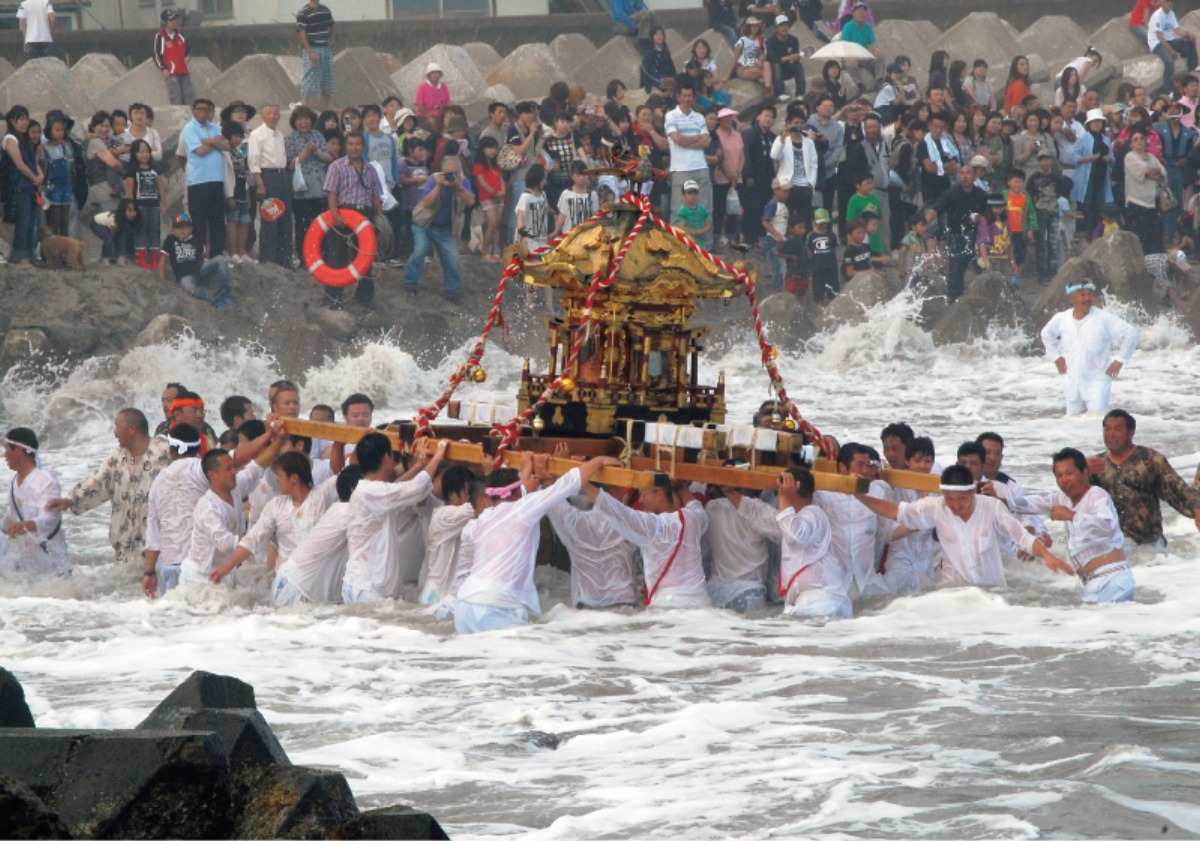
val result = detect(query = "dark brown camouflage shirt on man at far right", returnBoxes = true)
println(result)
[1092,446,1198,543]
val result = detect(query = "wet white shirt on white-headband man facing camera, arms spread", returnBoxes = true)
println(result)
[896,495,1033,587]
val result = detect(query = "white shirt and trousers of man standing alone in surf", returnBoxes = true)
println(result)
[1042,307,1138,413]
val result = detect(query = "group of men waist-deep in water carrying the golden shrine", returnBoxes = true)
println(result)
[0,380,1200,632]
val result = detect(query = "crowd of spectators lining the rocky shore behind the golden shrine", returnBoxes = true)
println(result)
[0,0,1200,307]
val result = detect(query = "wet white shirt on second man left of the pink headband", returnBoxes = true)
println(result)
[344,471,433,599]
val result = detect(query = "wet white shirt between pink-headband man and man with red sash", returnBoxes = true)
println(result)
[547,500,642,607]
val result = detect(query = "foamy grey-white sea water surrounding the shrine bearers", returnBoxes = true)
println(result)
[0,291,1200,840]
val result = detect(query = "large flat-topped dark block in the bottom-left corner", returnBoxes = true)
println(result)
[0,729,233,839]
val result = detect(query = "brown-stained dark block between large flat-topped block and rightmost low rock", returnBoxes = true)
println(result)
[234,765,359,839]
